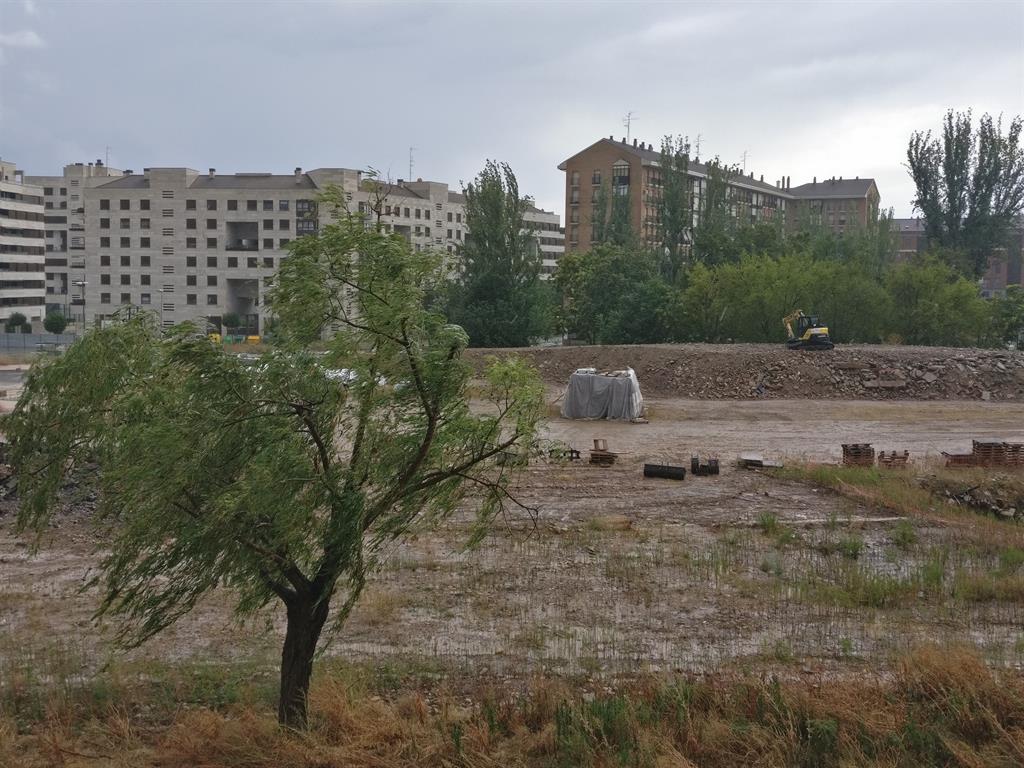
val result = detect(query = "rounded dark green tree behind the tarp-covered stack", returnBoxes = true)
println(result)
[555,245,680,344]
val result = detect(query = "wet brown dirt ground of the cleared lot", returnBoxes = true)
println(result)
[0,397,1024,681]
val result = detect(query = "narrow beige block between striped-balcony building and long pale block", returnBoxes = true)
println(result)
[26,160,122,324]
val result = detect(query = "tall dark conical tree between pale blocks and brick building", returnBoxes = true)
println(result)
[449,160,549,347]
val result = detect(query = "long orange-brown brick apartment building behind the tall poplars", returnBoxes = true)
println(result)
[558,136,879,251]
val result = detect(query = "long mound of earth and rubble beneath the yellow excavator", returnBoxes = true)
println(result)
[470,344,1024,400]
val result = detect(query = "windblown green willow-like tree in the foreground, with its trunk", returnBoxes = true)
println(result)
[5,204,544,727]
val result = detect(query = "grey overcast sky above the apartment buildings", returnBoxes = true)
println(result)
[0,0,1024,216]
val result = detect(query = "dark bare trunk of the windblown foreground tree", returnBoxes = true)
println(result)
[278,597,330,730]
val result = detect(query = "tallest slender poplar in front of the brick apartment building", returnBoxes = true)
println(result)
[657,136,693,284]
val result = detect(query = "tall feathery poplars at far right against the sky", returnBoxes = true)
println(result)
[906,110,1024,278]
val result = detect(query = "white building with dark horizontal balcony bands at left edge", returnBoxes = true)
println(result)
[0,160,46,331]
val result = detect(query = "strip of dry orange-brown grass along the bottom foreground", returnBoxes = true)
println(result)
[0,647,1024,768]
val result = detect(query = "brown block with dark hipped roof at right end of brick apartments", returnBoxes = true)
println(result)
[786,176,881,233]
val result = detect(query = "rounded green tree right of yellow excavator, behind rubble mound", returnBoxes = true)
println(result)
[886,254,989,346]
